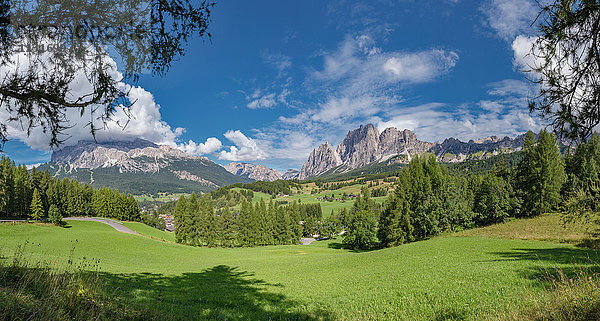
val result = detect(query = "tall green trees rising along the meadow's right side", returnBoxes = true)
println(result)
[368,130,600,248]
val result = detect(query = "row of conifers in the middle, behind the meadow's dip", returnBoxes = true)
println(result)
[174,194,332,247]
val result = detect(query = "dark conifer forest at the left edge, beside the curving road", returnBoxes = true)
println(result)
[0,157,140,223]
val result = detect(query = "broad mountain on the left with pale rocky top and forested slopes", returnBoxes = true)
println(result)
[38,139,252,194]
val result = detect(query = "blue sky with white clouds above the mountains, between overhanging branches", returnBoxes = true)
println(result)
[5,0,541,170]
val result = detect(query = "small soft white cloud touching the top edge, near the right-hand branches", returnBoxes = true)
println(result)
[482,0,539,41]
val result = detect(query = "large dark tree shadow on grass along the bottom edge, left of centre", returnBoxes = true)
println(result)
[103,265,335,320]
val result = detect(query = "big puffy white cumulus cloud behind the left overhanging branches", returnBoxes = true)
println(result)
[0,48,220,155]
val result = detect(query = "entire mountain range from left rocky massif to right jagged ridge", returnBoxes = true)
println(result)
[38,124,524,194]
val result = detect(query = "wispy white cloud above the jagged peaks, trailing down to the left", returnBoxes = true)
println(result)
[246,34,459,166]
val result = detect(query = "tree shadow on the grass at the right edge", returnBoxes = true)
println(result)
[492,247,600,286]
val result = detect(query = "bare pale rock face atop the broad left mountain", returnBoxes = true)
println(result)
[52,139,210,173]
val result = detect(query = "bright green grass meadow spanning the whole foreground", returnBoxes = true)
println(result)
[0,216,600,320]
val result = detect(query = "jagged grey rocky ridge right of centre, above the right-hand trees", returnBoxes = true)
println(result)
[299,124,525,179]
